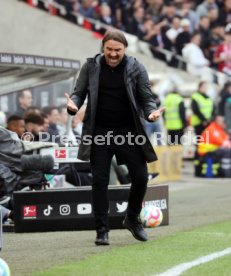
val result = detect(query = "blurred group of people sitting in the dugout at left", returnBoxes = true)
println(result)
[1,89,84,146]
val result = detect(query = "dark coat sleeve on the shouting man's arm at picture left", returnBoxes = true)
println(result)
[69,63,89,114]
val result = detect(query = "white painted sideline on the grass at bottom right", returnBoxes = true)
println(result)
[155,247,231,276]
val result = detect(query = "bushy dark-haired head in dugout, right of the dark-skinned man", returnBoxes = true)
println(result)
[24,113,44,142]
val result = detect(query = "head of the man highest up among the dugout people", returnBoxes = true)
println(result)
[15,89,32,117]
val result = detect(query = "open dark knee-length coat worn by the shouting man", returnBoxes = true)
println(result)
[68,54,157,162]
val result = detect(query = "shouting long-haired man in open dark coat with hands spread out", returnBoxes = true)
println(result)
[66,30,162,245]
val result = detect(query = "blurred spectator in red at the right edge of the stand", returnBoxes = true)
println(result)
[214,29,231,76]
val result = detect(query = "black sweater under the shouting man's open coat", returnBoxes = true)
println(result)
[95,58,134,129]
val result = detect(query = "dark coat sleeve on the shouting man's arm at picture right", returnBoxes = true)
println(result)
[136,63,157,120]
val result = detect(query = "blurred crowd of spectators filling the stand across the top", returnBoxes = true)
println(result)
[21,0,231,78]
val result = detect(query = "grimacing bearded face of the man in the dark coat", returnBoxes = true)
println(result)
[103,40,125,67]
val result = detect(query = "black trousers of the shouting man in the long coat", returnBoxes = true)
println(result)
[90,128,148,231]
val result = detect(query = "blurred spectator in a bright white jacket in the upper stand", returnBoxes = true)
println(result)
[182,33,209,77]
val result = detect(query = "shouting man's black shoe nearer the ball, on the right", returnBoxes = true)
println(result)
[123,217,148,241]
